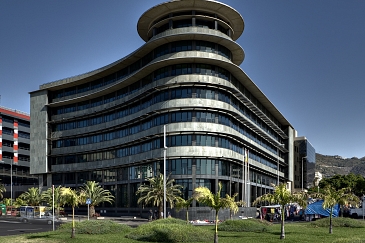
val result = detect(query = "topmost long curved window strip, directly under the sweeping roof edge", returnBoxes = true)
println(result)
[52,40,232,99]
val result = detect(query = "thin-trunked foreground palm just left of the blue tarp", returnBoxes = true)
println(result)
[253,183,308,239]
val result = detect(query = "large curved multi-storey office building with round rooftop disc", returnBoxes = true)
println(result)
[30,0,294,214]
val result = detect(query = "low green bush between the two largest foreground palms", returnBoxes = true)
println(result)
[218,219,272,232]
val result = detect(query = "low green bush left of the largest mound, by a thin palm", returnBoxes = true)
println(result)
[59,220,131,234]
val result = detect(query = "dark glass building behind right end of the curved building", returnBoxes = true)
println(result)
[294,137,316,190]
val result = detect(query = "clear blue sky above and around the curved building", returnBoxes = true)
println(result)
[0,0,365,158]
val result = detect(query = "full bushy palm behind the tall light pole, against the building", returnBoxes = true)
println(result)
[136,174,182,218]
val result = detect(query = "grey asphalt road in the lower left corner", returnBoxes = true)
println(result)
[0,217,58,236]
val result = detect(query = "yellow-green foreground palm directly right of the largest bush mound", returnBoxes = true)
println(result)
[193,182,238,243]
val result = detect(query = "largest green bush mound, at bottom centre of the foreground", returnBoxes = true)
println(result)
[126,218,214,242]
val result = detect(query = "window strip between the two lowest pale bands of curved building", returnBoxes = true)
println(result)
[51,135,277,169]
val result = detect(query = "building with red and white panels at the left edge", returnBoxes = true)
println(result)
[0,107,38,198]
